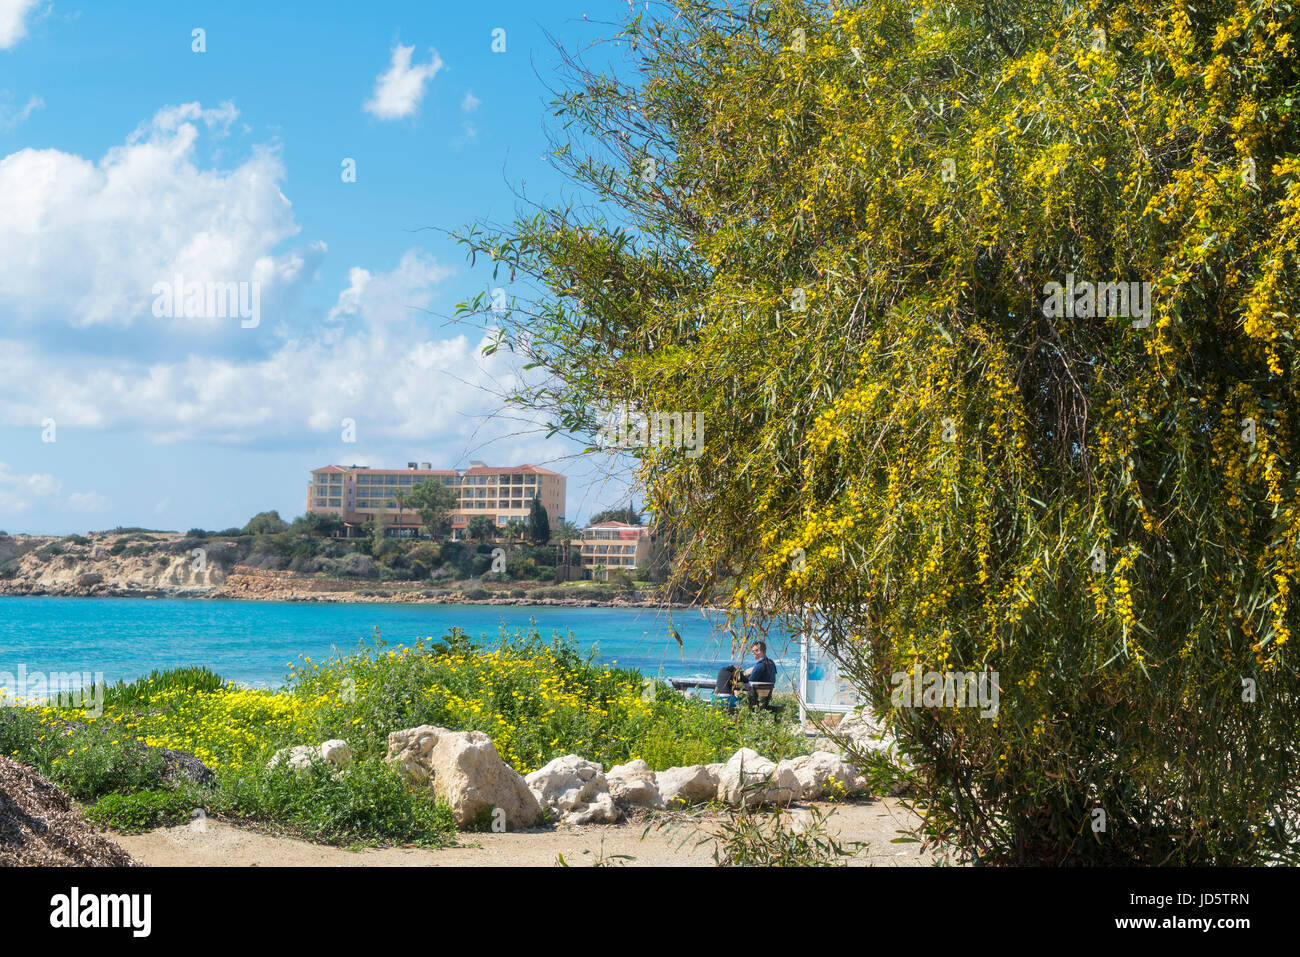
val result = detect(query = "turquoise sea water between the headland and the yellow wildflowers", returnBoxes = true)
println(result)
[0,598,798,687]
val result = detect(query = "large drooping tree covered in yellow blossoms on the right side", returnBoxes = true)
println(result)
[462,0,1300,863]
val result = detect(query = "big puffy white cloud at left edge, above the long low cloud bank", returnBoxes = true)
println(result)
[0,103,303,326]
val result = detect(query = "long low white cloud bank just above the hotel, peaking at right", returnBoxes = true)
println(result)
[0,250,553,460]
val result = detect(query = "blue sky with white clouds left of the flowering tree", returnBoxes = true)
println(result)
[0,0,642,533]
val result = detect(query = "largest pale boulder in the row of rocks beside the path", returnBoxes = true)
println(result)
[386,724,542,831]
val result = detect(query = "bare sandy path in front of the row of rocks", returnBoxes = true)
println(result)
[109,798,936,867]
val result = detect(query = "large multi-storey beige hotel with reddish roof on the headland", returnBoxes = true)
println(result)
[307,462,566,533]
